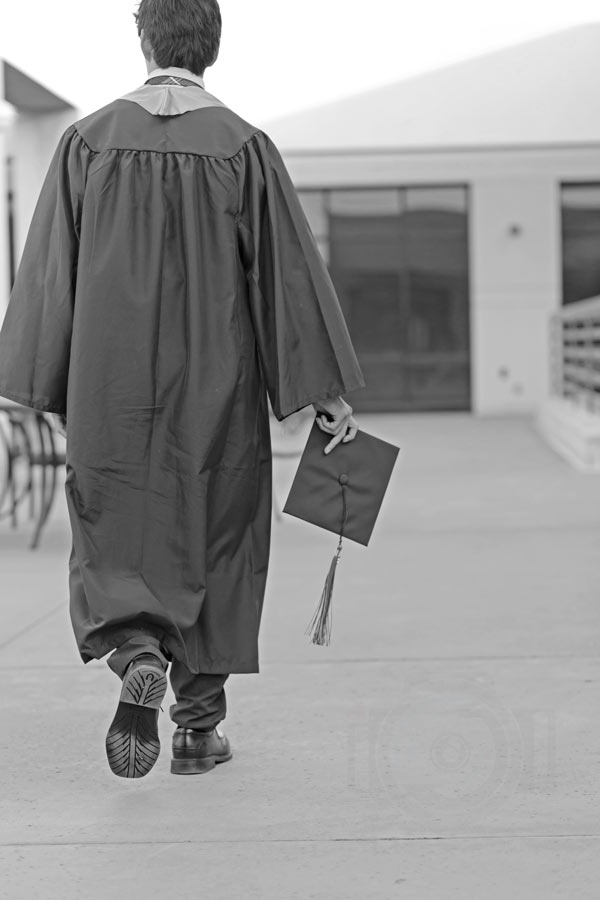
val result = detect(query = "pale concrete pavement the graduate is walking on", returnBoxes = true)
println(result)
[0,414,600,900]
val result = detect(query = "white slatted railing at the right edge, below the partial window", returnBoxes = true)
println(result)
[551,297,600,416]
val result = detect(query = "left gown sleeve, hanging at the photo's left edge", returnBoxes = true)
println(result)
[0,126,91,414]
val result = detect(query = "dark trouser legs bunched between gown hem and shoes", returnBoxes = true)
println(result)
[108,632,229,731]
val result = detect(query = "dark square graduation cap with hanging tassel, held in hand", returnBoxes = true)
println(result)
[283,421,399,645]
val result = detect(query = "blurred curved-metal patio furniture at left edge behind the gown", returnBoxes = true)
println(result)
[0,403,65,549]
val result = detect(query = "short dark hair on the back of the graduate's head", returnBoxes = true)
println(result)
[134,0,221,75]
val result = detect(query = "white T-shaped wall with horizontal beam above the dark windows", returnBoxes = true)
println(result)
[285,147,600,414]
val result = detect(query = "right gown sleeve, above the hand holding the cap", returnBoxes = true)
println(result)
[238,132,364,420]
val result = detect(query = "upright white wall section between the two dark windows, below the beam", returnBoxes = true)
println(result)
[470,175,561,413]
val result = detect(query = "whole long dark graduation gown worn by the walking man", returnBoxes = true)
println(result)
[0,85,363,673]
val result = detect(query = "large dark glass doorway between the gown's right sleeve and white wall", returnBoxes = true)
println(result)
[329,186,470,410]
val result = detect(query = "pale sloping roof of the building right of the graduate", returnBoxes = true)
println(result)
[266,23,600,156]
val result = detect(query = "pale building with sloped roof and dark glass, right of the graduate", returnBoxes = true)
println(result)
[267,26,600,414]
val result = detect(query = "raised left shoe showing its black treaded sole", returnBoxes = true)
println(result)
[106,656,167,778]
